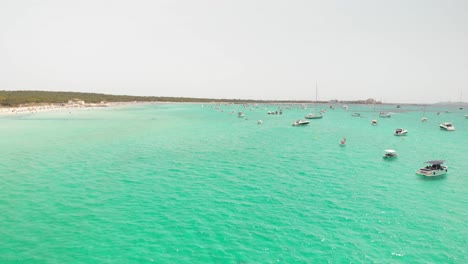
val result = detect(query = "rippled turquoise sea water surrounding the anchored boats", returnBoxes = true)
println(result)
[0,104,468,263]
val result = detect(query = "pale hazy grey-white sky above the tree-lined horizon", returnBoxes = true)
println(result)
[0,0,468,103]
